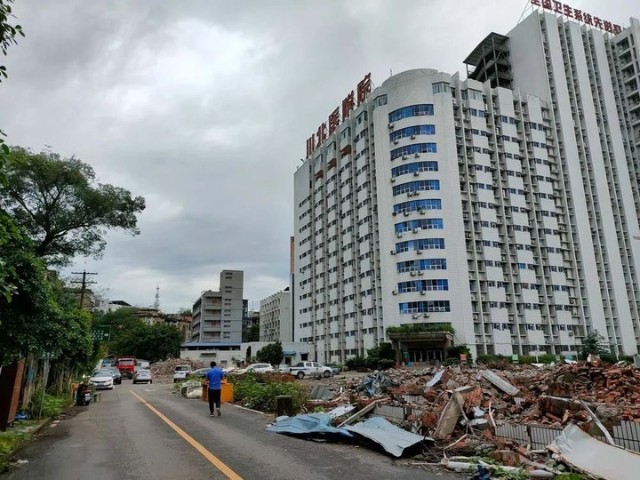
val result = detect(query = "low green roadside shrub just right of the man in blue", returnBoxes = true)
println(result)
[229,373,308,413]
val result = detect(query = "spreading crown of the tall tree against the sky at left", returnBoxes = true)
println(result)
[0,147,145,265]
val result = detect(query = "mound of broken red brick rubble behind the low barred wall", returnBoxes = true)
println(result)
[328,364,640,439]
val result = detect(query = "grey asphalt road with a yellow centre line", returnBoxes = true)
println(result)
[5,381,465,480]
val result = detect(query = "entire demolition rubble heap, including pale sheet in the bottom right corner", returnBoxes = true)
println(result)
[284,357,640,480]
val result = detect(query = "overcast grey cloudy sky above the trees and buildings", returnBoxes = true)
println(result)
[0,0,640,313]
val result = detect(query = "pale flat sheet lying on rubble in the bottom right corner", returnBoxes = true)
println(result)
[547,424,640,480]
